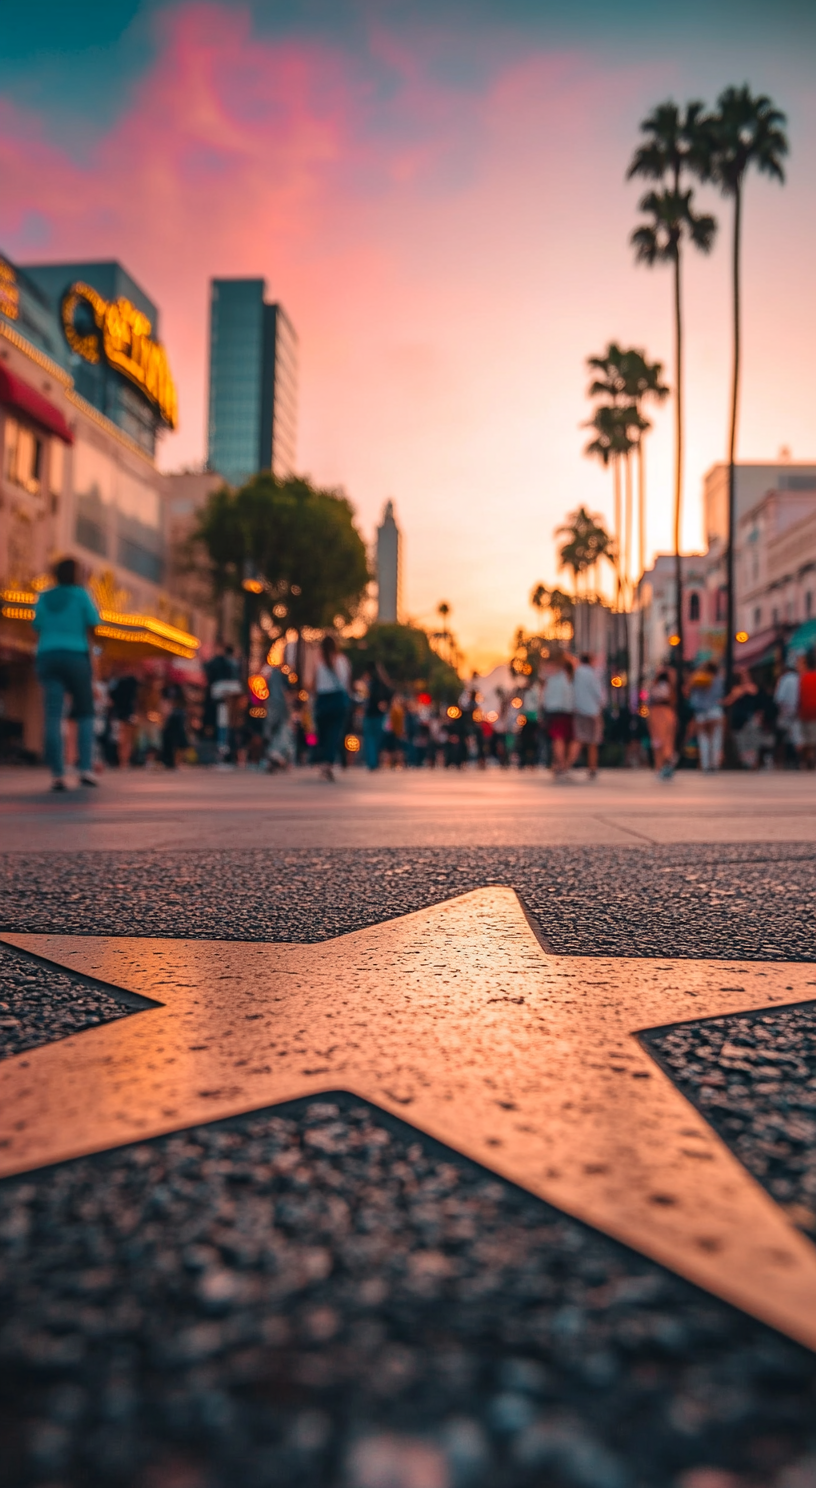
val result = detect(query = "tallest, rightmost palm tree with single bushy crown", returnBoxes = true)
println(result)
[707,83,789,687]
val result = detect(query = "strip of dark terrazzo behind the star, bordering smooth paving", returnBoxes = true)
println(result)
[0,845,816,961]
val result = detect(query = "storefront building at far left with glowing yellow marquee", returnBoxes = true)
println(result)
[0,259,213,757]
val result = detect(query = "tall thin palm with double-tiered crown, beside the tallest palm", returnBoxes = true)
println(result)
[627,101,716,679]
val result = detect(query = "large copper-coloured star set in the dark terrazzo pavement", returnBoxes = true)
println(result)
[0,888,816,1348]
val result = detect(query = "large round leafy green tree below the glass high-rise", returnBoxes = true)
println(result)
[195,475,371,631]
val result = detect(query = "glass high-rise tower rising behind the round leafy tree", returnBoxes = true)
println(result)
[207,278,298,485]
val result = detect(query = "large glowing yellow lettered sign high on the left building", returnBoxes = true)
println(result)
[63,284,179,429]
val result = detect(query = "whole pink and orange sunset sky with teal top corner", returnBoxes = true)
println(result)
[0,0,816,665]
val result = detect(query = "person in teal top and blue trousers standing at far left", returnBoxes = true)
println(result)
[34,558,100,790]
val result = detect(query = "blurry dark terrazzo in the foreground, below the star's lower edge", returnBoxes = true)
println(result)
[0,1097,816,1488]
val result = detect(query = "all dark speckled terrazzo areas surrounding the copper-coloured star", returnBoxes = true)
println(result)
[0,848,816,1488]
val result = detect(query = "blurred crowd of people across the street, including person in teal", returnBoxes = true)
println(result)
[25,558,816,790]
